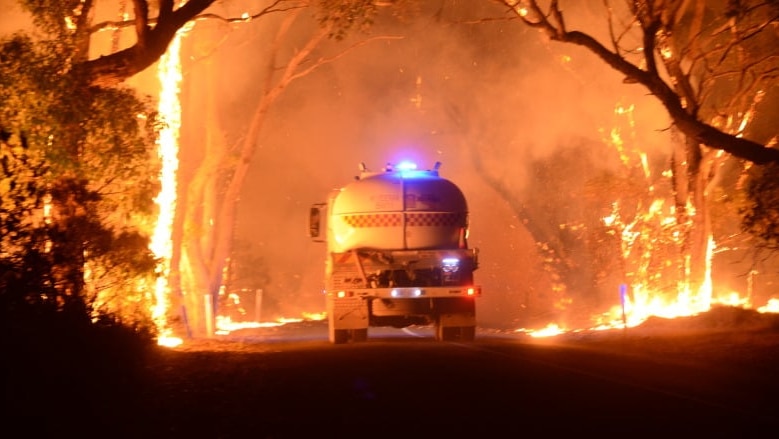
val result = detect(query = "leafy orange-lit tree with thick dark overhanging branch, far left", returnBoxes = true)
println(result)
[0,1,225,334]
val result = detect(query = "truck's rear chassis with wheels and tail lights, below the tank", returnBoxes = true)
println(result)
[325,249,481,344]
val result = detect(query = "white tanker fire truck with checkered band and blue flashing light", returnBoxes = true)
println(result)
[309,162,481,344]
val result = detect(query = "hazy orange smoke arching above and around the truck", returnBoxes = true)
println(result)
[189,1,668,327]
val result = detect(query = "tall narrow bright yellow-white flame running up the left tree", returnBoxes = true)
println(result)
[149,26,190,347]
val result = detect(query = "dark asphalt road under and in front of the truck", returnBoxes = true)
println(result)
[126,326,779,438]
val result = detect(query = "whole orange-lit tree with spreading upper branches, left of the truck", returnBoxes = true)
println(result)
[172,1,408,334]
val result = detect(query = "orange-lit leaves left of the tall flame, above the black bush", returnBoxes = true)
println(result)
[0,17,159,330]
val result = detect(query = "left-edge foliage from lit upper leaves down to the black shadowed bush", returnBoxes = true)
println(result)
[0,0,168,424]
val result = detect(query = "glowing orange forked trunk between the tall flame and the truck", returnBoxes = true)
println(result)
[174,11,336,334]
